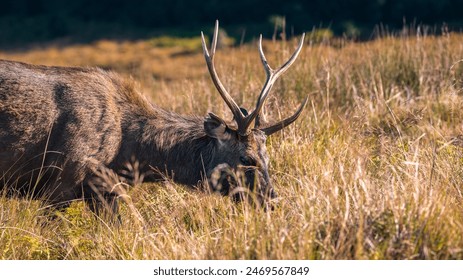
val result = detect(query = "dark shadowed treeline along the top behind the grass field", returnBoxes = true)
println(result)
[0,0,463,46]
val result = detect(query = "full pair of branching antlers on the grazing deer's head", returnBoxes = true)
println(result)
[201,20,307,136]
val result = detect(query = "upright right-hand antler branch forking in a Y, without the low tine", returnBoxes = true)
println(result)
[246,33,305,129]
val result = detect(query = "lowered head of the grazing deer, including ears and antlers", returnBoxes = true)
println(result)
[201,21,308,207]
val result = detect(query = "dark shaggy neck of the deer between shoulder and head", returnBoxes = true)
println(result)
[118,109,215,185]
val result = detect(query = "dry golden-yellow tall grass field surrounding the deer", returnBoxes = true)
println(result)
[0,31,463,259]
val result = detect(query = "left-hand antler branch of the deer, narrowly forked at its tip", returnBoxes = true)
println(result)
[201,20,247,130]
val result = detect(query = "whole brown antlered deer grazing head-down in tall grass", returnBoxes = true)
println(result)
[0,21,308,214]
